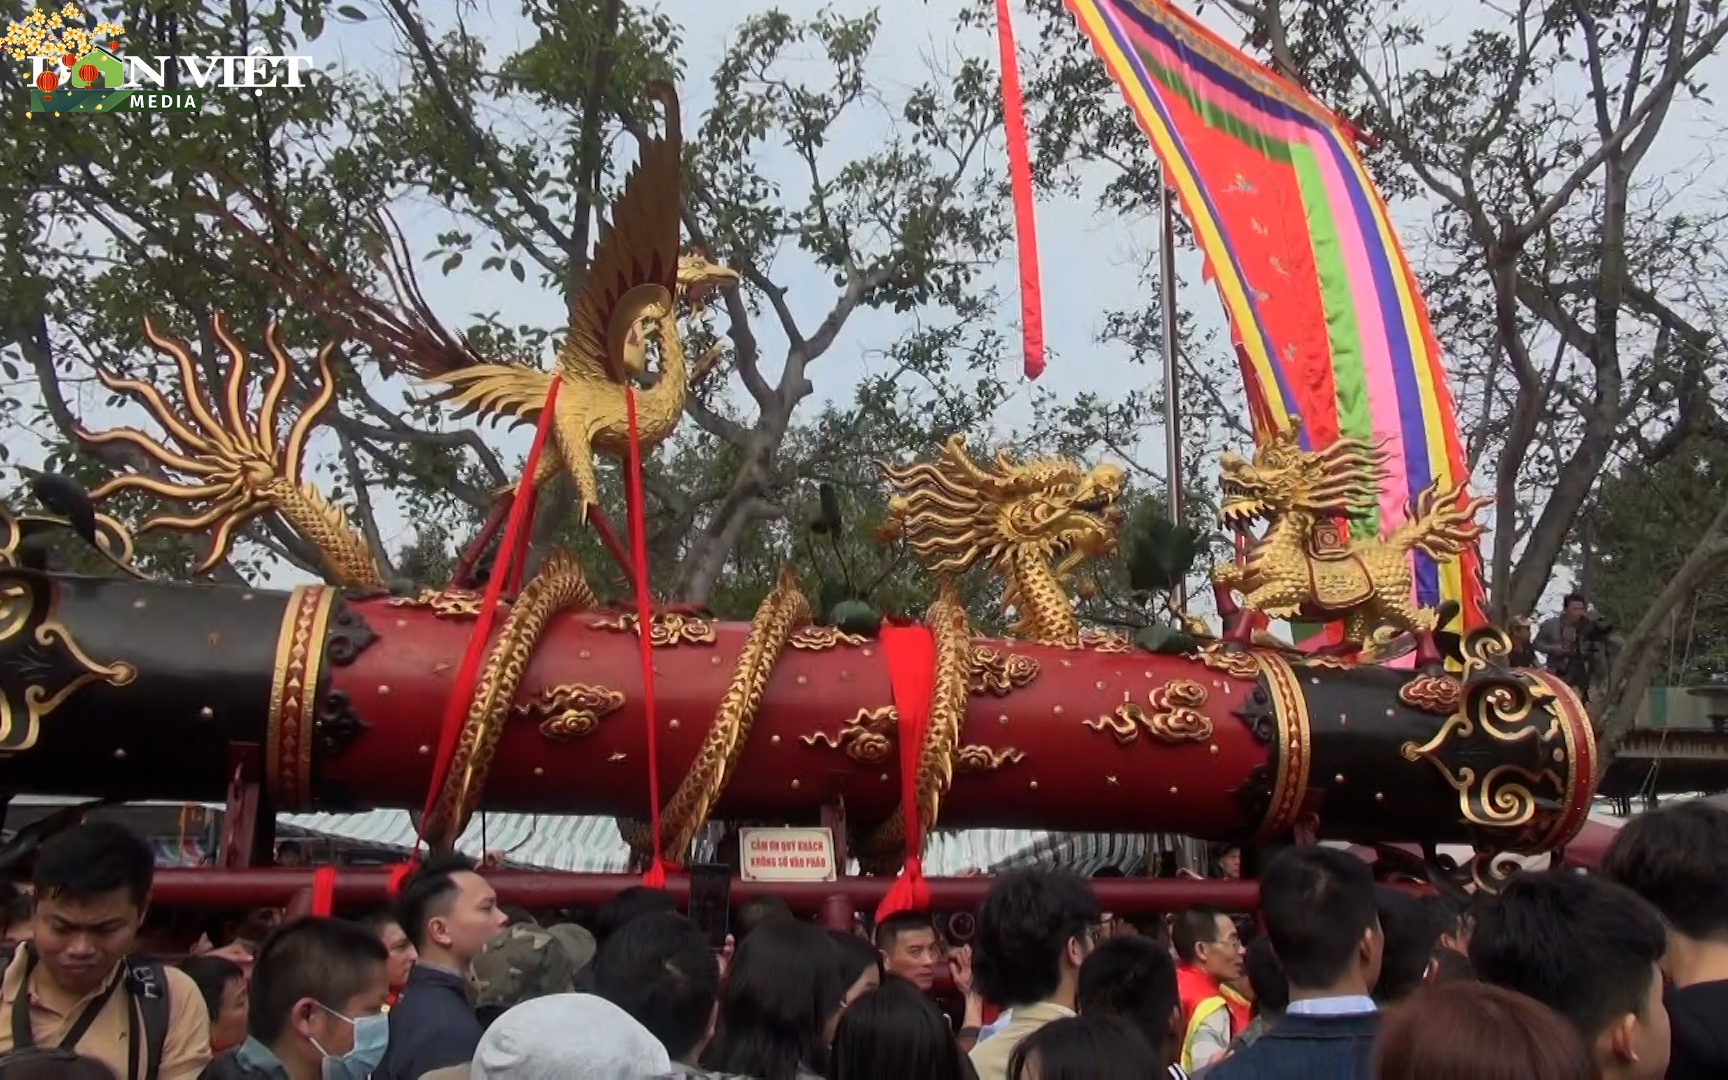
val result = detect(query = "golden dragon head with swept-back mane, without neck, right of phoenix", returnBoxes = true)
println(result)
[876,435,1123,574]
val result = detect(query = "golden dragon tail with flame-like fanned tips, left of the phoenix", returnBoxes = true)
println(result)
[74,314,385,589]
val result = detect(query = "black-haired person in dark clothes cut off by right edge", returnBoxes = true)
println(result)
[1600,800,1728,1080]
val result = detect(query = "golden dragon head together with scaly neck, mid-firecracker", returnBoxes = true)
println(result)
[878,435,1123,648]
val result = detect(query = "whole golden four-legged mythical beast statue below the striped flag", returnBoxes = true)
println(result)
[1211,422,1490,645]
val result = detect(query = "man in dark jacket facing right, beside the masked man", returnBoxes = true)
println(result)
[373,855,506,1080]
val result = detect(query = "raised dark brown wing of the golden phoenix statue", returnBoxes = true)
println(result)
[558,83,684,384]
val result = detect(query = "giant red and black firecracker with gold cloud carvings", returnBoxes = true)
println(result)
[0,559,1595,870]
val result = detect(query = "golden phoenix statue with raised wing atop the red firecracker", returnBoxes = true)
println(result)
[427,83,738,515]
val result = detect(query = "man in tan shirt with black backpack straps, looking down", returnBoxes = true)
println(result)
[0,823,211,1080]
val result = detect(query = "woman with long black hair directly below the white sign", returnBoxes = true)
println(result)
[702,921,845,1080]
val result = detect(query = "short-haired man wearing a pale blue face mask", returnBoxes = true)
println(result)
[200,918,391,1080]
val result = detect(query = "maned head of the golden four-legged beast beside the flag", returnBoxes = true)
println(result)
[1218,416,1386,529]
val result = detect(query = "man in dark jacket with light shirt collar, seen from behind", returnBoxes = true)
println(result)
[1206,847,1384,1080]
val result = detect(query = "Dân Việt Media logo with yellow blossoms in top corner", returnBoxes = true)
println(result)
[0,3,313,116]
